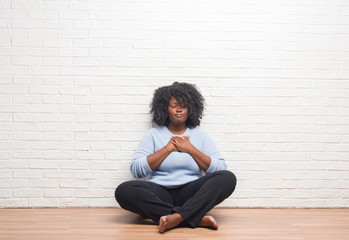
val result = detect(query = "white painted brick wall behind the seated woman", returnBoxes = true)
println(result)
[0,0,349,207]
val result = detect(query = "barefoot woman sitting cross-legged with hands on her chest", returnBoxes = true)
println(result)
[115,82,236,233]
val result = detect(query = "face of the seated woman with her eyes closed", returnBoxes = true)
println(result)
[167,96,188,125]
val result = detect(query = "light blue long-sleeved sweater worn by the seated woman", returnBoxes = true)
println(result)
[130,126,227,188]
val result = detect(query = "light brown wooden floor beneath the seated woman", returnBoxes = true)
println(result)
[0,208,349,240]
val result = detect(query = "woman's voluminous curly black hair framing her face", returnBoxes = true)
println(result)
[150,82,205,128]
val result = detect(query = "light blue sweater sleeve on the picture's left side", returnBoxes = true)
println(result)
[130,131,154,178]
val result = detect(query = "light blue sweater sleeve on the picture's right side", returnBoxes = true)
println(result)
[203,134,227,173]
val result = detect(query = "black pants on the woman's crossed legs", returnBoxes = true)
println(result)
[115,170,236,227]
